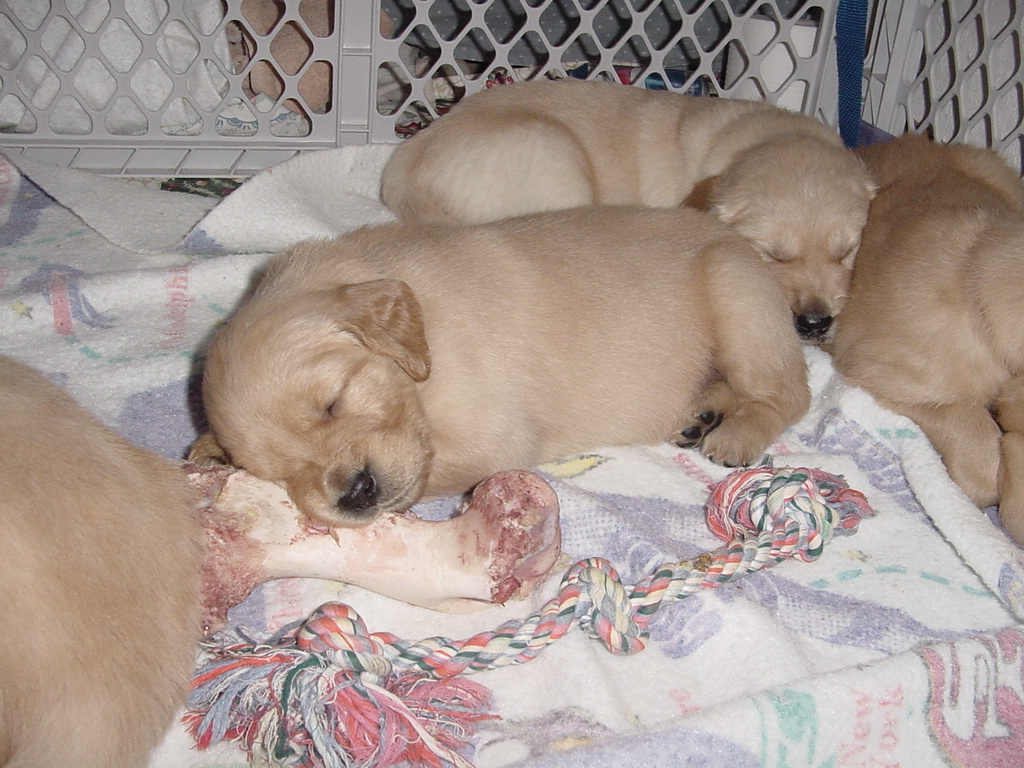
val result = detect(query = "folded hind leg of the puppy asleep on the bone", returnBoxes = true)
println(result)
[680,240,811,466]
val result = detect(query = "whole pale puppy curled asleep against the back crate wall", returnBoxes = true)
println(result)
[382,80,873,342]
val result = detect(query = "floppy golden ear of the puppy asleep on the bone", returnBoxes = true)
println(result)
[332,280,430,381]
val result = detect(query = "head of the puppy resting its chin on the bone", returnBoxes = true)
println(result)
[203,280,433,525]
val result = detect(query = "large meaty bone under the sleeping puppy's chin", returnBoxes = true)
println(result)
[187,465,561,632]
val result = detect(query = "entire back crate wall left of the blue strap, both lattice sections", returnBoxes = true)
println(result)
[0,0,836,175]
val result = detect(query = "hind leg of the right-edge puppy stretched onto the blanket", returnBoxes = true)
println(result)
[882,400,1001,507]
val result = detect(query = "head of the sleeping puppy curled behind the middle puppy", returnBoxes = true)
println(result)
[690,135,876,343]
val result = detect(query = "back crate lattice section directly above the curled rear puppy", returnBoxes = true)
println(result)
[374,0,836,140]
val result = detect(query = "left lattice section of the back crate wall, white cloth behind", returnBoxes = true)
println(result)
[0,0,372,174]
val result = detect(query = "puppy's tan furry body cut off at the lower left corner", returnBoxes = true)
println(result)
[0,356,201,768]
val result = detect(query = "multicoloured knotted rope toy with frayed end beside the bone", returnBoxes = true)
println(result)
[185,466,873,768]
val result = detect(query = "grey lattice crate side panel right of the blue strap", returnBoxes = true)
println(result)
[864,0,1024,174]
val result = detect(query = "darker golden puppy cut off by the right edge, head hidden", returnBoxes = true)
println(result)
[833,135,1024,543]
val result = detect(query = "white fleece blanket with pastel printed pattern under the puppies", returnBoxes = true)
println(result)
[0,147,1024,768]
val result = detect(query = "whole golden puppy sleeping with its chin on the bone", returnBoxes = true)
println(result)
[193,207,809,525]
